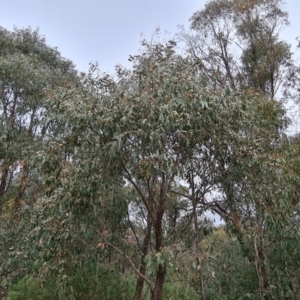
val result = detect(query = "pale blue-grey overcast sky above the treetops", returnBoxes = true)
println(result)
[0,0,300,73]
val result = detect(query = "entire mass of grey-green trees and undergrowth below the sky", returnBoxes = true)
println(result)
[0,0,300,300]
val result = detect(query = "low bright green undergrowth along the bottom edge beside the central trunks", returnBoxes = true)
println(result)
[7,261,199,300]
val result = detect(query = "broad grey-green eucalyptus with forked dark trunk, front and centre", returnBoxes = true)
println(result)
[40,34,292,299]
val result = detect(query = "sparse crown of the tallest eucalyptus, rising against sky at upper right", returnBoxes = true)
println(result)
[181,0,295,98]
